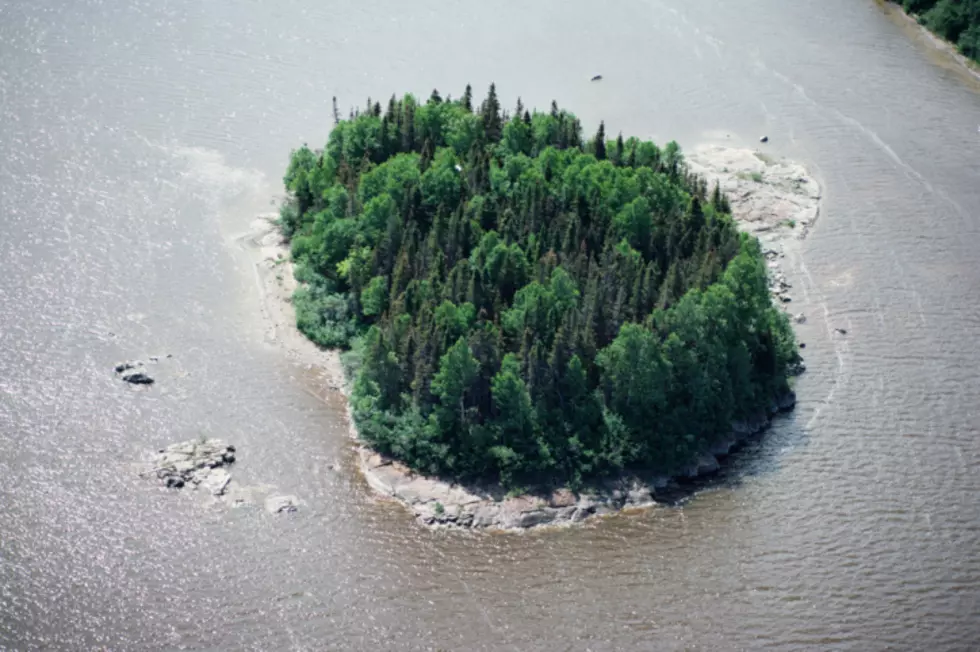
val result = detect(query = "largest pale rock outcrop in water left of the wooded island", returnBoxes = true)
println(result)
[152,439,235,496]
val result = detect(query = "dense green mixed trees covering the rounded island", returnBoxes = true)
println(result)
[281,85,798,487]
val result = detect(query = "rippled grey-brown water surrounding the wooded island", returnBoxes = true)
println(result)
[0,0,980,651]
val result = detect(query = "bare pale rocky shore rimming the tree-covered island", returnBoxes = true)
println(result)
[247,146,820,530]
